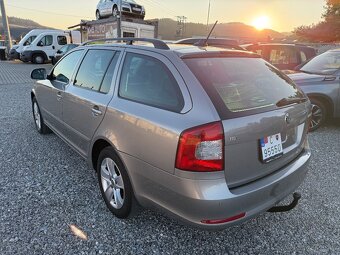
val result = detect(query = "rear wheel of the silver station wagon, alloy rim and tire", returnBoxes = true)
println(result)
[97,147,137,219]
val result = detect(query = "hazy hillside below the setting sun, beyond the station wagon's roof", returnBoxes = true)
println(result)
[159,19,284,41]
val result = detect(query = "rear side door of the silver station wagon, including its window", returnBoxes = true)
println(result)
[63,49,120,156]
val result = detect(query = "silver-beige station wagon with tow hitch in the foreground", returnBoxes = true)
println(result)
[31,38,311,229]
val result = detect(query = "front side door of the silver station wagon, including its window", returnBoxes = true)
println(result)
[36,50,83,133]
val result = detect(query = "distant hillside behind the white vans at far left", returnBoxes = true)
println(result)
[0,16,51,39]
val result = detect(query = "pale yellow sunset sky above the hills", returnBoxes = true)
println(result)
[5,0,325,32]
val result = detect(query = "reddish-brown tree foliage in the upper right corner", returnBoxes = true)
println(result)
[294,0,340,42]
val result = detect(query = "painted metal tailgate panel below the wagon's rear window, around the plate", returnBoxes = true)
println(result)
[223,103,309,187]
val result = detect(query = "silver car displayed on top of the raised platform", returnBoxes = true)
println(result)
[96,0,145,20]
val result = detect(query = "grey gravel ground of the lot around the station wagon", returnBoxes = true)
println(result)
[0,62,340,254]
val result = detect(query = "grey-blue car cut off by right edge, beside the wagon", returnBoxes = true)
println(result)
[289,49,340,131]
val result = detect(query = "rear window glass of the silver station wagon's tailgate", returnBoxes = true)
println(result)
[184,57,305,118]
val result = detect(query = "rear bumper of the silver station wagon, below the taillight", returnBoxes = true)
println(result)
[123,140,311,230]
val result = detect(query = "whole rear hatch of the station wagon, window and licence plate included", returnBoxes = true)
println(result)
[185,54,310,187]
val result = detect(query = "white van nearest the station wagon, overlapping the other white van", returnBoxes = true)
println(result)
[20,31,81,64]
